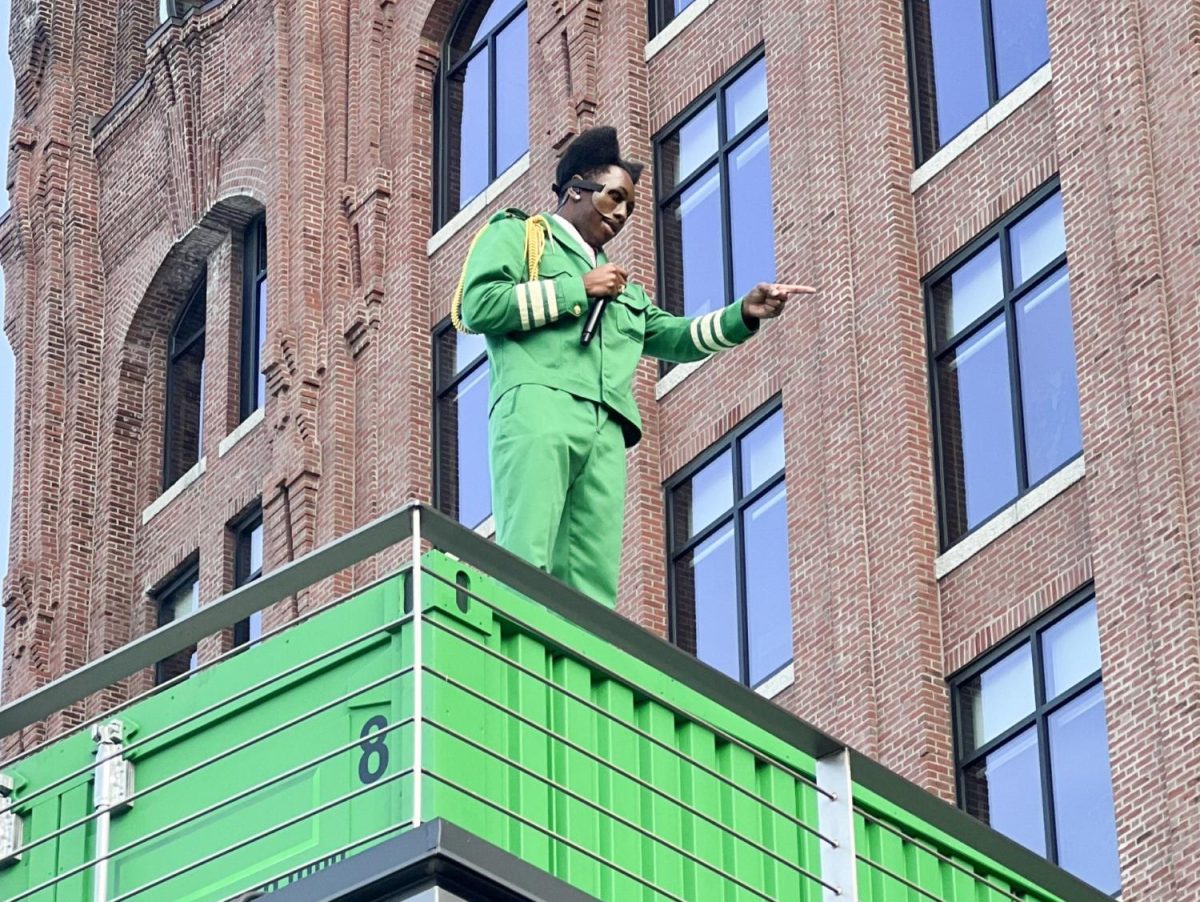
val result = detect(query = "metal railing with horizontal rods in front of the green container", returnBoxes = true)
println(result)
[0,504,1105,902]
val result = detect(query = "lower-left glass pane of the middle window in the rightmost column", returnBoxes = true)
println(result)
[937,319,1016,542]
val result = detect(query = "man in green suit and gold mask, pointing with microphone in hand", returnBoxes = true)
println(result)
[451,127,814,607]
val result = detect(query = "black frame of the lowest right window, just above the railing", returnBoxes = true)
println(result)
[947,583,1120,892]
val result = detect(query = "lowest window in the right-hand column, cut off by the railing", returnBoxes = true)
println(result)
[950,593,1121,894]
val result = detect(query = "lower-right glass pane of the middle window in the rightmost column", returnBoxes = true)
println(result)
[1016,266,1084,486]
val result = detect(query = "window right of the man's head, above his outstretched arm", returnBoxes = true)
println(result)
[655,55,775,331]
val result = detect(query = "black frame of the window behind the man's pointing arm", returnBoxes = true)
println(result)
[652,44,774,375]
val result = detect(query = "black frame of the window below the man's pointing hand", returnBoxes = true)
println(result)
[662,395,796,688]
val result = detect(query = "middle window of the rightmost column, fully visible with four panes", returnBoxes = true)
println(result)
[925,185,1082,547]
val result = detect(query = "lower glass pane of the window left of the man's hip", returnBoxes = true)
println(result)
[437,361,492,528]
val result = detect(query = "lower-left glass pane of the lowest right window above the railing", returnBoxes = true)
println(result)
[962,727,1046,855]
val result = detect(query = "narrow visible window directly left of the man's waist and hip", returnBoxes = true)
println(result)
[433,324,492,529]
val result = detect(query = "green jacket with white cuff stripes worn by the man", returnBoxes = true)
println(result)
[462,210,755,447]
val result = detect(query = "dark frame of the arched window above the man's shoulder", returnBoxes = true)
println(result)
[433,0,529,231]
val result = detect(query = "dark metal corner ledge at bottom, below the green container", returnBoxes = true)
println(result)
[270,818,596,902]
